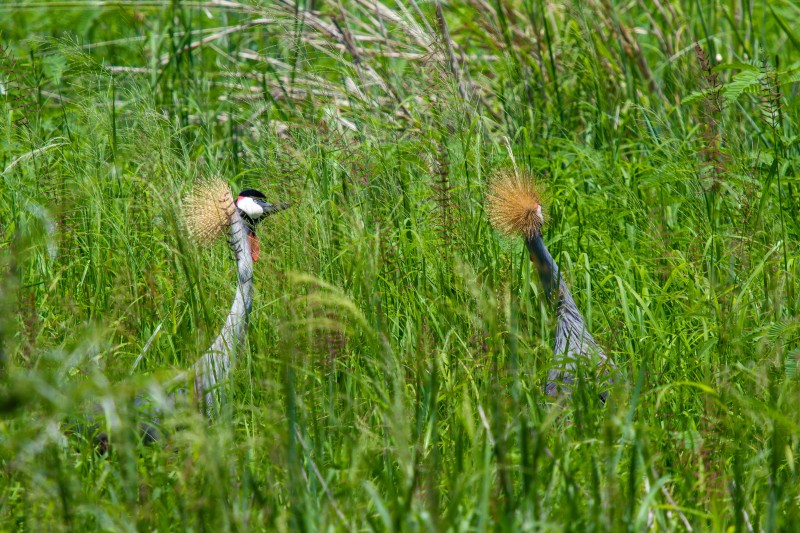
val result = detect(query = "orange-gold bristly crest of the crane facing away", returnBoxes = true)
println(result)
[486,168,544,238]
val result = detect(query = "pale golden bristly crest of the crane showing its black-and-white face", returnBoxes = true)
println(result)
[183,177,236,246]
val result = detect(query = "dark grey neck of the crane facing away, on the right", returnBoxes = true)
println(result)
[525,231,614,401]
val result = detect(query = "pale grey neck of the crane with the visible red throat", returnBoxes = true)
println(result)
[194,210,253,414]
